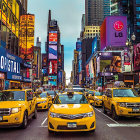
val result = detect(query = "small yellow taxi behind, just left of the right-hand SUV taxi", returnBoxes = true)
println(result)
[93,91,103,106]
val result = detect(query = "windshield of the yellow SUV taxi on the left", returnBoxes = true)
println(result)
[0,91,25,102]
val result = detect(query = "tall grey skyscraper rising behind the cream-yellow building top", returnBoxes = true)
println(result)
[85,0,104,26]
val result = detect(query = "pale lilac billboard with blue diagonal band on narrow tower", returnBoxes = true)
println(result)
[49,45,57,59]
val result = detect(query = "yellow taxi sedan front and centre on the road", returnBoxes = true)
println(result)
[48,92,96,133]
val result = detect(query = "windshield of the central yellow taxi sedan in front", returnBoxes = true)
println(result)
[54,94,88,104]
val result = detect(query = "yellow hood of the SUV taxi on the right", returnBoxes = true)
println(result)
[114,97,140,103]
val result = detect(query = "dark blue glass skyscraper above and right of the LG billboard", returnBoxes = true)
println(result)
[111,0,140,43]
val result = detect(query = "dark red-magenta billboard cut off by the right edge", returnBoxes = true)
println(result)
[134,43,140,71]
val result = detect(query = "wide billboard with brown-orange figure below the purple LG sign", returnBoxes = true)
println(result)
[97,52,122,73]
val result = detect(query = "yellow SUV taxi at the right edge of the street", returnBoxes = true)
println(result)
[103,87,140,120]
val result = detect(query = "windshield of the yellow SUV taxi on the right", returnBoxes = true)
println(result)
[113,89,139,97]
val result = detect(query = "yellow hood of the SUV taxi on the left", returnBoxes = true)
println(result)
[0,101,25,108]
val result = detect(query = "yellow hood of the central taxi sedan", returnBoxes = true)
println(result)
[50,104,93,114]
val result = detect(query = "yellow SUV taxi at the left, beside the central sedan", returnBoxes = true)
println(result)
[0,89,37,128]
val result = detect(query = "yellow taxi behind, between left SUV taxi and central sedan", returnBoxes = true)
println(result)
[37,92,50,110]
